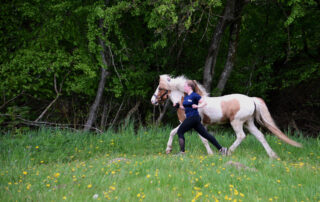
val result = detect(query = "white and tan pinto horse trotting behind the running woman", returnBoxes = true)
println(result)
[151,74,302,159]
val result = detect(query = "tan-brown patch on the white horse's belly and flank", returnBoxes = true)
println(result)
[221,99,240,122]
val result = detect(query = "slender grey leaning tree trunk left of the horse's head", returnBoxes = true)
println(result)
[84,19,111,131]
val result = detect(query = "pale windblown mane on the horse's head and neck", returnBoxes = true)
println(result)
[159,74,209,97]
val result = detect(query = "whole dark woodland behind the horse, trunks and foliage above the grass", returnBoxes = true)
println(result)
[0,0,320,136]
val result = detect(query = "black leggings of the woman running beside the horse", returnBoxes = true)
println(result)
[178,116,221,152]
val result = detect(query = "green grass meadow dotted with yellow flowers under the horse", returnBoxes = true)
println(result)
[0,127,320,201]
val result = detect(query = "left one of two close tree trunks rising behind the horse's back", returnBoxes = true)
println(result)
[203,0,235,93]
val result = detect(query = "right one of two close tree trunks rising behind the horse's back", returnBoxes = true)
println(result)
[217,0,249,95]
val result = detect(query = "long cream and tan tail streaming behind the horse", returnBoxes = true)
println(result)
[253,97,302,147]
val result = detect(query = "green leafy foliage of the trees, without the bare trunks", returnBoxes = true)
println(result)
[0,0,320,131]
